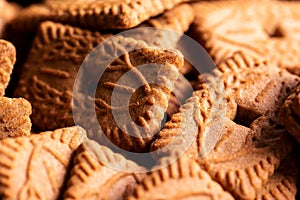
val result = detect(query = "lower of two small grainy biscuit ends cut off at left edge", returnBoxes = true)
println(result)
[0,97,31,139]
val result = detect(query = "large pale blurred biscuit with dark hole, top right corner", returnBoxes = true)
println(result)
[191,1,300,73]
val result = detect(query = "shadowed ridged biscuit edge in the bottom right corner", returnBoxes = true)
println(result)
[255,154,299,200]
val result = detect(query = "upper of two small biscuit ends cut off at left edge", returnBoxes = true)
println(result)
[0,40,16,96]
